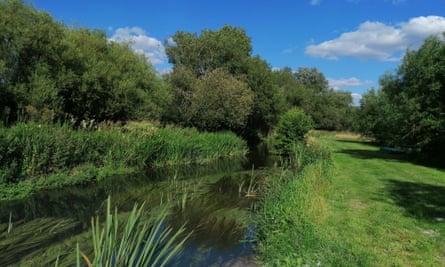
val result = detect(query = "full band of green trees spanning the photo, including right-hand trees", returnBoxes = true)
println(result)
[0,0,445,161]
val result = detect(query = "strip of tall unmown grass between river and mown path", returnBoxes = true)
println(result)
[257,143,338,266]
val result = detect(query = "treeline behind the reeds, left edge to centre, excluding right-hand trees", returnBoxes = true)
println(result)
[0,0,352,140]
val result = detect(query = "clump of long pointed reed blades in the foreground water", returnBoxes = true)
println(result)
[76,197,188,267]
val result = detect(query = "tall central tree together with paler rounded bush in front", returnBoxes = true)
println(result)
[166,25,281,137]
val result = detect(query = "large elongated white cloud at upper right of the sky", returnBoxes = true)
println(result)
[305,16,445,61]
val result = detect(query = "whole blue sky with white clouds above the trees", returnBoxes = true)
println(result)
[30,0,445,103]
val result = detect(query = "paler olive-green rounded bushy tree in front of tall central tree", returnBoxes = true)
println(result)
[186,69,253,131]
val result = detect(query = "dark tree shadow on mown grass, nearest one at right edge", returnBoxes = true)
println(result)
[385,179,445,222]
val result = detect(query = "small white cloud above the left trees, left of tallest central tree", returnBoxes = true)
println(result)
[110,27,167,65]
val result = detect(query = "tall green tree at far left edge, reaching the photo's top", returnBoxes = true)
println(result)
[0,0,64,120]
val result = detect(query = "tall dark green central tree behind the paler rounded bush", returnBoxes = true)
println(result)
[166,25,280,137]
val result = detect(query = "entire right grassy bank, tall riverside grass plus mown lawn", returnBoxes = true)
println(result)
[255,133,445,266]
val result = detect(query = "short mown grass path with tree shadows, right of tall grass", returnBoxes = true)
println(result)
[320,134,445,266]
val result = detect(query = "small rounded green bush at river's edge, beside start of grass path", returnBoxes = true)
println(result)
[272,108,312,155]
